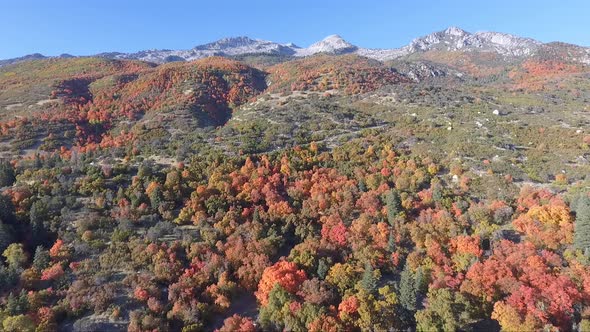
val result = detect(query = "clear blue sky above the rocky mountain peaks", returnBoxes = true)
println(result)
[0,0,590,59]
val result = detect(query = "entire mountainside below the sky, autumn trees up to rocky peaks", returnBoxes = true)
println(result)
[0,28,590,331]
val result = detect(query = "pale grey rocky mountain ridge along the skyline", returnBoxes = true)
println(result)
[0,27,590,66]
